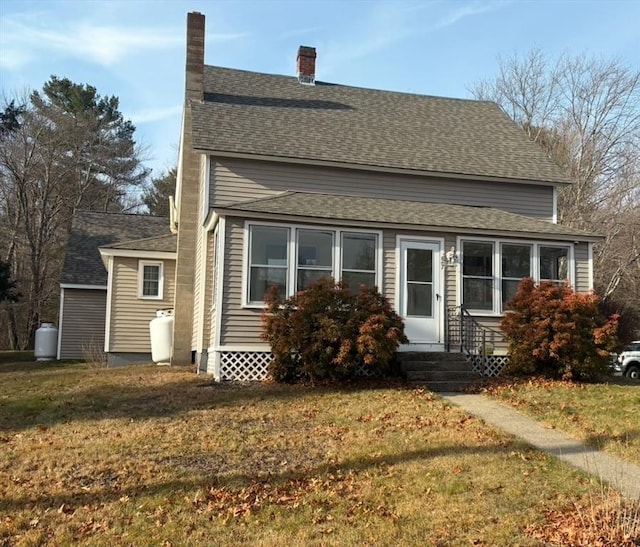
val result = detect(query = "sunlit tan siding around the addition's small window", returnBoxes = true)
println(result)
[109,257,175,352]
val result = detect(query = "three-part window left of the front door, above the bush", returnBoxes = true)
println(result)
[244,223,381,306]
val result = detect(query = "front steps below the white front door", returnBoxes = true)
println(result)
[397,352,482,392]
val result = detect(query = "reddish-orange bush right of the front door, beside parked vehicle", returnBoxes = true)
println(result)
[501,278,618,381]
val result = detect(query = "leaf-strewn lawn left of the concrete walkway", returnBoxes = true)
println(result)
[0,361,640,546]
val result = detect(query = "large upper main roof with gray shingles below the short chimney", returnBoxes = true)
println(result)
[192,66,569,183]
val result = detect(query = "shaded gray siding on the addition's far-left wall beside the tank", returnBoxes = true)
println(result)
[60,289,107,359]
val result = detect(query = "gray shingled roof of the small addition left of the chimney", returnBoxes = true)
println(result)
[60,211,169,286]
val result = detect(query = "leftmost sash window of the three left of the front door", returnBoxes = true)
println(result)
[248,225,289,304]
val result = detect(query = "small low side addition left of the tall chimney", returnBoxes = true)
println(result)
[57,211,176,366]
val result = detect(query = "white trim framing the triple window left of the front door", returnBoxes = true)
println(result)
[242,220,384,309]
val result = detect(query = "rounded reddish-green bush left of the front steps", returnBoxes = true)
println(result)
[262,278,408,382]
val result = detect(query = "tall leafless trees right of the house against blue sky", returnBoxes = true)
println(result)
[472,50,640,318]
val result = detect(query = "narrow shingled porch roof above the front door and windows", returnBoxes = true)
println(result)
[219,192,598,239]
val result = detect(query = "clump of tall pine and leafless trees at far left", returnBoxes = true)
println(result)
[0,77,148,349]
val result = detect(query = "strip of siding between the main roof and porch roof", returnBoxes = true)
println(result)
[210,158,553,220]
